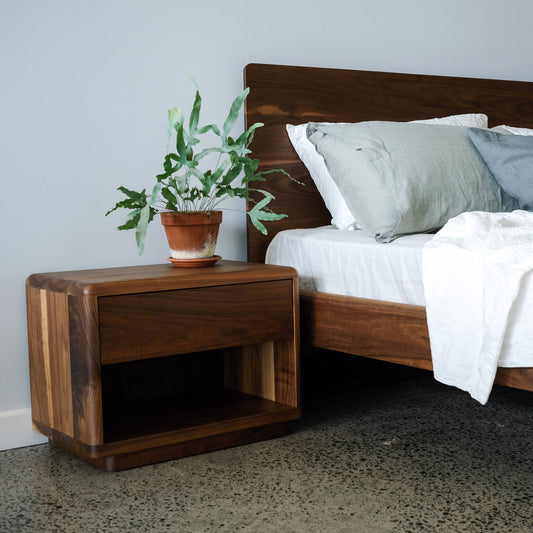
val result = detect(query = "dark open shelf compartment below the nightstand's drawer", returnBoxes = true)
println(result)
[102,343,299,454]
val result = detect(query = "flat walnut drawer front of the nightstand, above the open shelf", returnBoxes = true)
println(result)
[98,280,294,364]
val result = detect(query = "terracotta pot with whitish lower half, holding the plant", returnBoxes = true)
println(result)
[161,211,222,264]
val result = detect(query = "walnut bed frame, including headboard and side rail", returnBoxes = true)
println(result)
[244,64,533,391]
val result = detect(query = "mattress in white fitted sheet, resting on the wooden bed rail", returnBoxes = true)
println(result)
[265,226,533,367]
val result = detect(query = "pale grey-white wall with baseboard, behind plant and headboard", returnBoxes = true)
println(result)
[0,0,533,449]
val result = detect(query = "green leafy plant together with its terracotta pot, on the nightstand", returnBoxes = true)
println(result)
[106,81,288,266]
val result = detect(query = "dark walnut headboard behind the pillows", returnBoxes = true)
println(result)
[244,64,533,262]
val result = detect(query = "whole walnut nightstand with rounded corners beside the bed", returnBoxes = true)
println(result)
[26,261,301,470]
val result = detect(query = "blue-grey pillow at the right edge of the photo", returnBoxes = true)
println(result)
[468,128,533,211]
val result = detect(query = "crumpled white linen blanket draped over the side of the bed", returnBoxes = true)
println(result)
[422,211,533,404]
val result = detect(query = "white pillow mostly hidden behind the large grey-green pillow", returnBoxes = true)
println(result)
[286,113,488,230]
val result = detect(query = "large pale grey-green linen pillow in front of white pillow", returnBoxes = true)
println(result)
[307,122,516,242]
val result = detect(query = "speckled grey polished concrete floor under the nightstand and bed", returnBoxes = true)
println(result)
[0,358,533,533]
